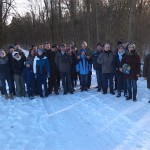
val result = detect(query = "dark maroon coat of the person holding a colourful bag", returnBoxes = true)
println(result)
[119,50,140,80]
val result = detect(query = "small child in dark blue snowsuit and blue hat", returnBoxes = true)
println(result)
[23,61,35,99]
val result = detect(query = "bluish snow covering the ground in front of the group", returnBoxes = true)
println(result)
[0,49,150,150]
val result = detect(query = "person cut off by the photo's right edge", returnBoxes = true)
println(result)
[143,54,150,103]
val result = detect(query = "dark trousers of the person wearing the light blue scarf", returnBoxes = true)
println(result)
[116,73,127,94]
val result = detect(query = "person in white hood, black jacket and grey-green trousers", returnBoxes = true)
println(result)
[11,51,25,97]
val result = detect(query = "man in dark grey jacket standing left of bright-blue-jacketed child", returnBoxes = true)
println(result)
[56,44,73,95]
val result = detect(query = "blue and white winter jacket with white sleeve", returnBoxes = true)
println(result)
[33,55,50,76]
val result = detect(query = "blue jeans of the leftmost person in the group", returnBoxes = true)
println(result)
[1,79,13,95]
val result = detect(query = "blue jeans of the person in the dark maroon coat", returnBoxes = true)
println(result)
[127,79,137,98]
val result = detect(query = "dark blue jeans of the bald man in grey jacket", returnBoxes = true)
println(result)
[102,73,114,92]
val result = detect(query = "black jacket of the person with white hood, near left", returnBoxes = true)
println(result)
[11,57,24,75]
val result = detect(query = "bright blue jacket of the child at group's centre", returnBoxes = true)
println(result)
[76,55,92,75]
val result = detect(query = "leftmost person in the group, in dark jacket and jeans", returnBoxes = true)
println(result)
[0,49,14,100]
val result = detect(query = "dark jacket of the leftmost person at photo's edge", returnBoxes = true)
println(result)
[0,57,12,79]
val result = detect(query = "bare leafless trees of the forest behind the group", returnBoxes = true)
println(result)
[1,0,150,50]
